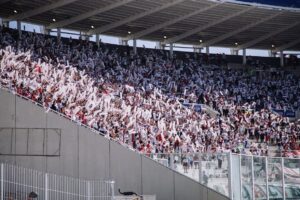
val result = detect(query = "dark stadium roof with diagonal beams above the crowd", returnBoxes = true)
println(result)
[0,0,300,51]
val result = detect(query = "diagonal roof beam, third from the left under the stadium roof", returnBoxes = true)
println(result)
[88,0,184,35]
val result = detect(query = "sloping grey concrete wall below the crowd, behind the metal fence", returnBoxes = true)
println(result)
[0,89,228,200]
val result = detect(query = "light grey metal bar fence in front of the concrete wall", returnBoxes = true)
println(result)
[0,163,114,200]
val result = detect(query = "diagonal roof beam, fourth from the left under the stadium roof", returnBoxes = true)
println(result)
[128,3,221,40]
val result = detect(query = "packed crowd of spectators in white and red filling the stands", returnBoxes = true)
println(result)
[0,26,300,155]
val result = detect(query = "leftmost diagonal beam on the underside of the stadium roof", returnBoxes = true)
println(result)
[7,0,77,21]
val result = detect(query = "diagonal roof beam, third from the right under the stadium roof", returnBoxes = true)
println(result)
[203,12,284,46]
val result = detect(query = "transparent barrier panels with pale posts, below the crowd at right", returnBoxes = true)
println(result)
[145,153,300,200]
